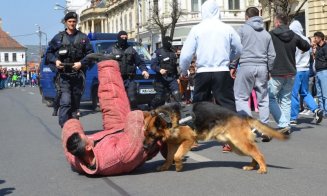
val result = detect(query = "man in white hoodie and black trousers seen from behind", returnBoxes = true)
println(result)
[180,0,242,152]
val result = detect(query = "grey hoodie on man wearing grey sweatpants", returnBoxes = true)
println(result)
[239,16,276,71]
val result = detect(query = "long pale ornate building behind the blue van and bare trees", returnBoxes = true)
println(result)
[79,0,259,51]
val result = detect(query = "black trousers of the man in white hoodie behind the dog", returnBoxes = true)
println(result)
[193,71,236,112]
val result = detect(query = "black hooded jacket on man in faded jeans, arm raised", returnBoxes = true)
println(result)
[270,25,311,76]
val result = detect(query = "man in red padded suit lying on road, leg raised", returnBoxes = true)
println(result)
[62,60,160,176]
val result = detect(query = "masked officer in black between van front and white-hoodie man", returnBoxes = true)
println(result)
[151,36,182,109]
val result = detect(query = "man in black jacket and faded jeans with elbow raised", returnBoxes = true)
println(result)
[269,14,310,134]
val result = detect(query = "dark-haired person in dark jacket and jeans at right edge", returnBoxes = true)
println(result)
[314,32,327,116]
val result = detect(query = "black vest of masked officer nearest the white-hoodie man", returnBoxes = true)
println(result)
[157,48,177,75]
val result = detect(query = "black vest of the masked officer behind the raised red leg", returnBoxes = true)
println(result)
[111,45,136,76]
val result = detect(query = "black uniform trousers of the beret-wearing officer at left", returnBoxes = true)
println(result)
[59,72,84,127]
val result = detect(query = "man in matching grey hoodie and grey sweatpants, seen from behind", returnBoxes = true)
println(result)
[230,7,276,142]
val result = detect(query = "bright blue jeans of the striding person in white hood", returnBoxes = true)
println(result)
[291,70,318,120]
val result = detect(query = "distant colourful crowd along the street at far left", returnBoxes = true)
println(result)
[0,66,38,90]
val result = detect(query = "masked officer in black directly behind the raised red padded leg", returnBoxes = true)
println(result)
[110,31,149,110]
